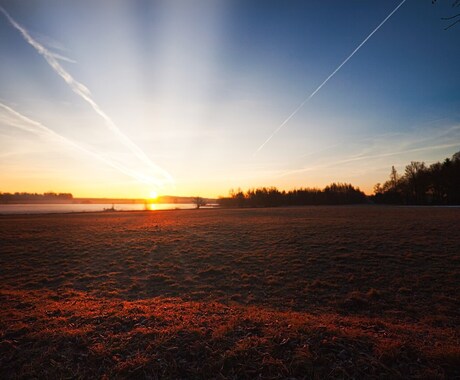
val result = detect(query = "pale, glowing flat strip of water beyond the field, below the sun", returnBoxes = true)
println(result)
[0,203,196,214]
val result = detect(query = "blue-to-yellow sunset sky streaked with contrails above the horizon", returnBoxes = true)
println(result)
[0,0,460,198]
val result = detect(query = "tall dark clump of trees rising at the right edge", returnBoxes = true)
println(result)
[372,152,460,205]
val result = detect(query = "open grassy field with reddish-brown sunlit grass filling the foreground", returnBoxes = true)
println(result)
[0,206,460,379]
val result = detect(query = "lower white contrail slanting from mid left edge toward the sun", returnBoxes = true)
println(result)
[0,103,163,187]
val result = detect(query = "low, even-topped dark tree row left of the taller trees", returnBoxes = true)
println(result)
[218,183,366,207]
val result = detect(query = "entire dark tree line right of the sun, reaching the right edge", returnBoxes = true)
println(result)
[218,152,460,207]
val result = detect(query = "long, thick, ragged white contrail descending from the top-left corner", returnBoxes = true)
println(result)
[0,6,174,187]
